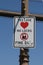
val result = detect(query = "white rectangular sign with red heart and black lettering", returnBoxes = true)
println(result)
[14,16,35,48]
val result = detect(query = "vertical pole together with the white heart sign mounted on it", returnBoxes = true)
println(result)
[14,0,35,65]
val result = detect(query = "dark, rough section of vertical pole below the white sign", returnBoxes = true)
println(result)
[19,48,29,65]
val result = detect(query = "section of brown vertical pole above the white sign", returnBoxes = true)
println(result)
[21,0,28,16]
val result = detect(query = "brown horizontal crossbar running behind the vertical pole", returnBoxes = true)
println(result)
[0,10,43,21]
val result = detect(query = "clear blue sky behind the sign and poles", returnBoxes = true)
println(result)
[0,0,43,65]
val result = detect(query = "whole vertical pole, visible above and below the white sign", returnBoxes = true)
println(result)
[19,0,29,65]
